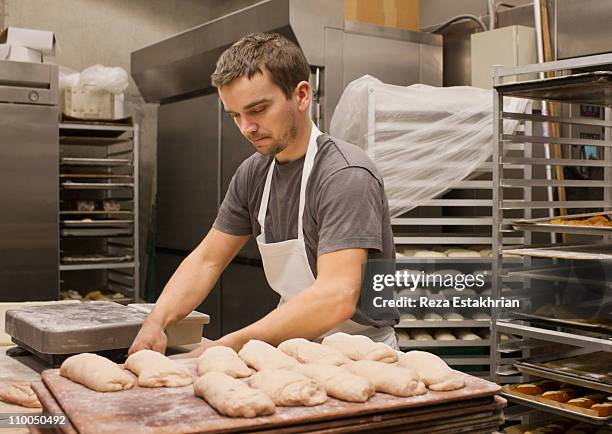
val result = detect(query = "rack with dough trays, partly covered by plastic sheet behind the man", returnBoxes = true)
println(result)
[391,126,530,378]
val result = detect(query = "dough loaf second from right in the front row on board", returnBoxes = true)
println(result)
[345,360,427,396]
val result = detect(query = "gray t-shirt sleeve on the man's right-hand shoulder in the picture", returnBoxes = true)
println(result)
[316,167,383,256]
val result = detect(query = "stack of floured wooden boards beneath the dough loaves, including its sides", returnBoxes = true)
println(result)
[34,359,505,434]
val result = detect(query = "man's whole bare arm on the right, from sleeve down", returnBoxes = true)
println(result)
[216,249,367,355]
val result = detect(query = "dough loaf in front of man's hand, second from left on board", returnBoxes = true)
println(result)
[125,350,193,387]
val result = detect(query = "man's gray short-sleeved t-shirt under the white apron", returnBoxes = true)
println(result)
[213,134,399,327]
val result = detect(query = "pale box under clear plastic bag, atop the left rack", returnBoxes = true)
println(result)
[61,86,124,120]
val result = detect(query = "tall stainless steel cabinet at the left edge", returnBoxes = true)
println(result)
[0,61,59,301]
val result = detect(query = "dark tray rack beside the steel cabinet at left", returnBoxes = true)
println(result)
[59,121,140,303]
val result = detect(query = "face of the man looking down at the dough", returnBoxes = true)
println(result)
[219,68,299,155]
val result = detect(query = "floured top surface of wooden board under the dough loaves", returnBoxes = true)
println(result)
[41,359,503,434]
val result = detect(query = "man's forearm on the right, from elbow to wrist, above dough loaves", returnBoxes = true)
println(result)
[219,282,359,350]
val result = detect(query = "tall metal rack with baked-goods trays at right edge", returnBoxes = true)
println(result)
[491,54,612,425]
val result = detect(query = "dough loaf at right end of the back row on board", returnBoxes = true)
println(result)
[322,333,397,363]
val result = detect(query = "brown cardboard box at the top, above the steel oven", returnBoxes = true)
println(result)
[344,0,419,32]
